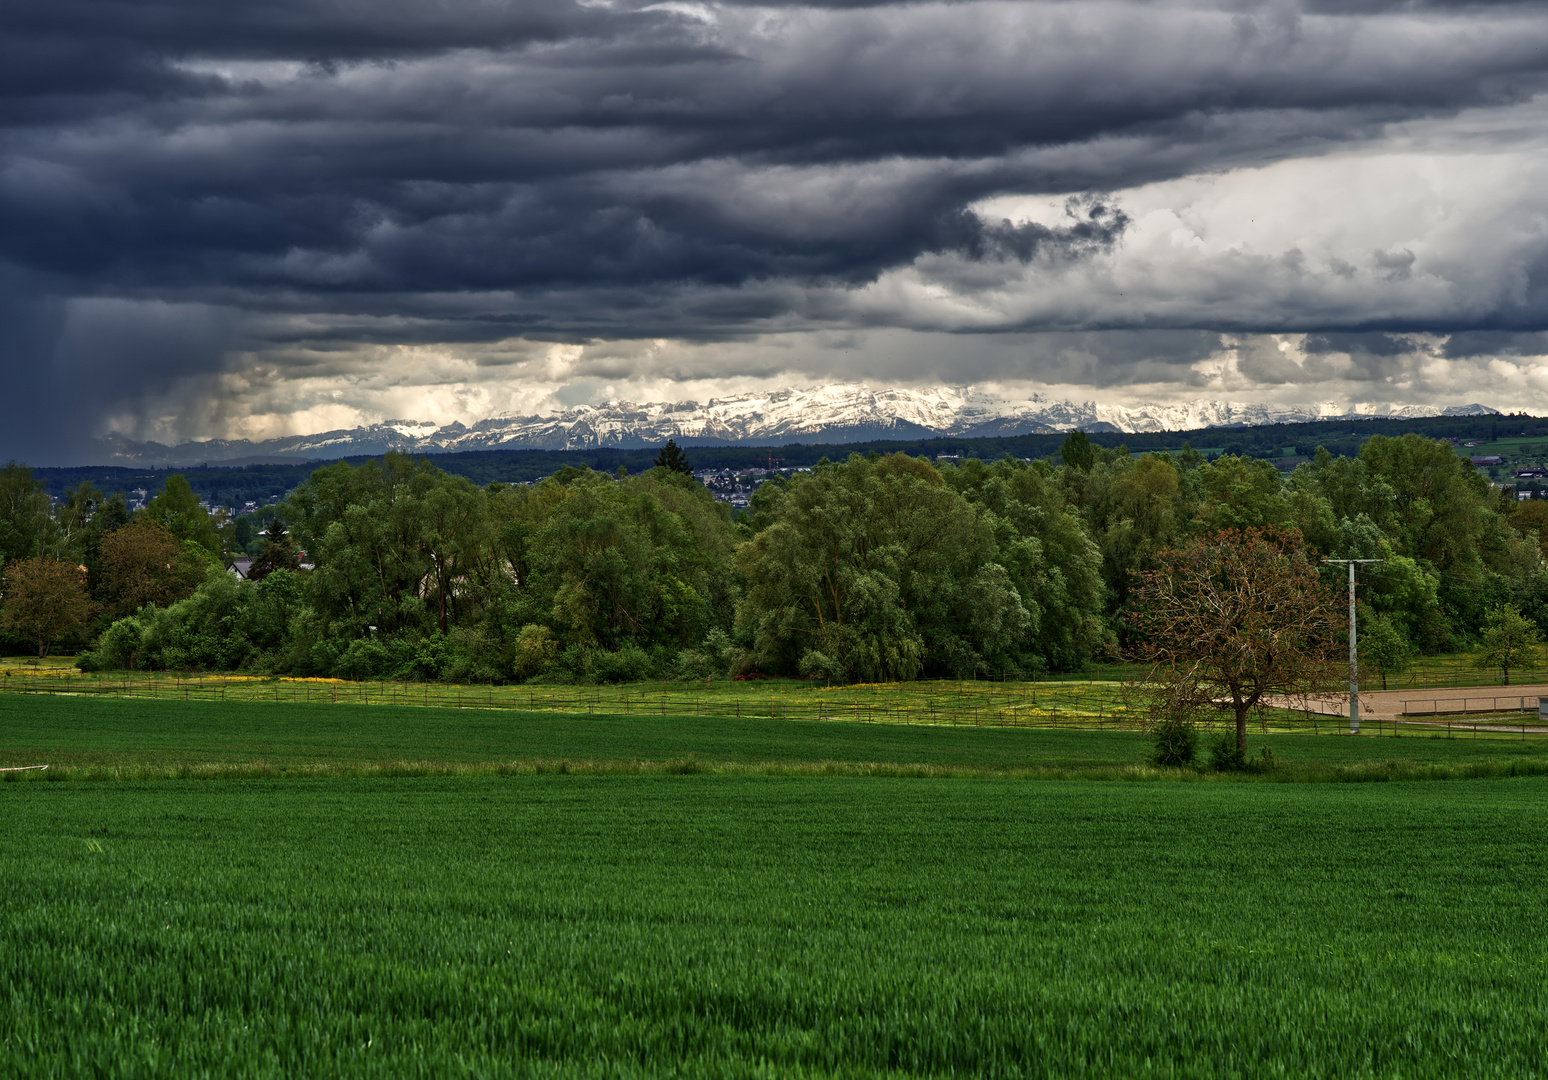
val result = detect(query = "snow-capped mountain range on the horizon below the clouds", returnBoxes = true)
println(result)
[90,384,1497,466]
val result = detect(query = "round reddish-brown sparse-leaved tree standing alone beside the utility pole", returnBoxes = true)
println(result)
[1128,529,1348,750]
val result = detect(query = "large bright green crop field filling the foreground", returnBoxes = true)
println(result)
[0,770,1548,1077]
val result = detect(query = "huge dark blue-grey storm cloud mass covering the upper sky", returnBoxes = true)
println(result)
[0,0,1548,454]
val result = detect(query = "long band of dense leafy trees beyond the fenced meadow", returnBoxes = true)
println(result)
[0,433,1548,681]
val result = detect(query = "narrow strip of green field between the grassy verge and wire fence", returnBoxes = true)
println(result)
[9,695,1548,781]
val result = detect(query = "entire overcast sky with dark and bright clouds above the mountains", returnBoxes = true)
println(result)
[0,0,1548,463]
